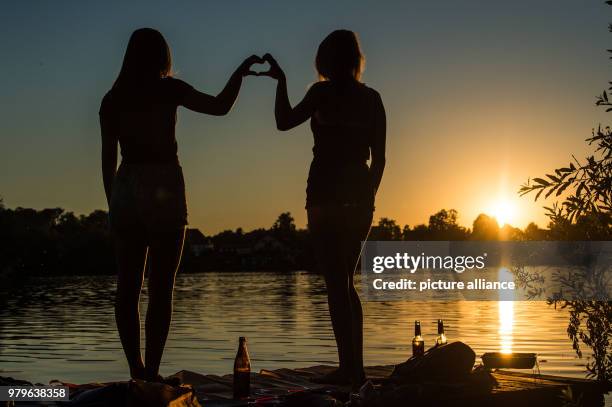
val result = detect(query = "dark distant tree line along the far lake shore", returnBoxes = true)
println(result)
[0,200,602,276]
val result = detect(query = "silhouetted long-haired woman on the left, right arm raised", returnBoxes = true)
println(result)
[100,28,262,381]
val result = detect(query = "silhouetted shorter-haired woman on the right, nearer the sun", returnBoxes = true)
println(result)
[264,30,386,387]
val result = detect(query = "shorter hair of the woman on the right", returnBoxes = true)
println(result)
[315,30,365,81]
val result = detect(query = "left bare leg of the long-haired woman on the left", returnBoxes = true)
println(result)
[114,236,147,379]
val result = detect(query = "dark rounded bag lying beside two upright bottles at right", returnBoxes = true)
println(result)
[391,342,476,381]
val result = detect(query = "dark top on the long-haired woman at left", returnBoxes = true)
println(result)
[100,77,193,164]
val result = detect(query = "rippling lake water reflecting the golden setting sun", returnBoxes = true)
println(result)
[0,272,585,383]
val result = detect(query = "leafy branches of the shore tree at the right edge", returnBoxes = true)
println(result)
[519,1,612,382]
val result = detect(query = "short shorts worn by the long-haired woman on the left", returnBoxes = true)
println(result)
[109,163,187,236]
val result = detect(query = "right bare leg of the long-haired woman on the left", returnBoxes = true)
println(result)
[145,228,185,380]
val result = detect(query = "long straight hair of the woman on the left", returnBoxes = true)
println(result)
[113,28,172,88]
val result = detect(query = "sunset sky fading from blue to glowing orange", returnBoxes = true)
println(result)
[0,0,612,233]
